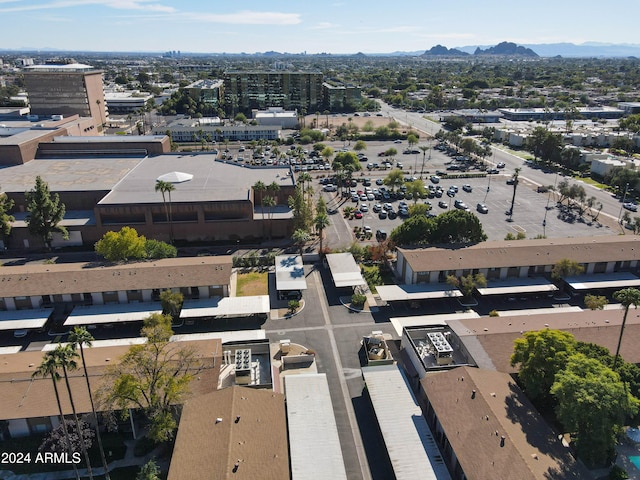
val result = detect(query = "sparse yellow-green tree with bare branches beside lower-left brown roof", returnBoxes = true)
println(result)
[99,314,203,442]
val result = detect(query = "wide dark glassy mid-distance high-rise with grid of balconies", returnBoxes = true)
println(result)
[224,70,323,116]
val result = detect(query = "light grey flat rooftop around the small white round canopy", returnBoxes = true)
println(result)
[100,154,294,205]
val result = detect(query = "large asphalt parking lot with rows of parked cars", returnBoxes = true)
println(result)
[317,142,618,247]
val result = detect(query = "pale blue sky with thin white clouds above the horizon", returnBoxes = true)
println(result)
[0,0,640,53]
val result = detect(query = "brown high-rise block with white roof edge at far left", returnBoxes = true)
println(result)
[24,63,108,132]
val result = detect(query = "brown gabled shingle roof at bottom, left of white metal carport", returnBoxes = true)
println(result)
[168,386,289,480]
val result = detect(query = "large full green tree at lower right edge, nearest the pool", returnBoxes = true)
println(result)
[550,353,640,468]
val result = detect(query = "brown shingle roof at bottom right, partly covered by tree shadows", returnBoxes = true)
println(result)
[421,367,591,480]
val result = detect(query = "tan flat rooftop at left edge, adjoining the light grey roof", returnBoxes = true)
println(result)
[0,158,141,193]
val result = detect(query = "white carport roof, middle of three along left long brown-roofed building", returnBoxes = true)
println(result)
[64,302,162,327]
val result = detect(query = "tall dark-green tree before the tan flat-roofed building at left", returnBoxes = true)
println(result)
[25,175,69,250]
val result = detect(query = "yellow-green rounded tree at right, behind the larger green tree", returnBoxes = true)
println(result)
[511,328,576,403]
